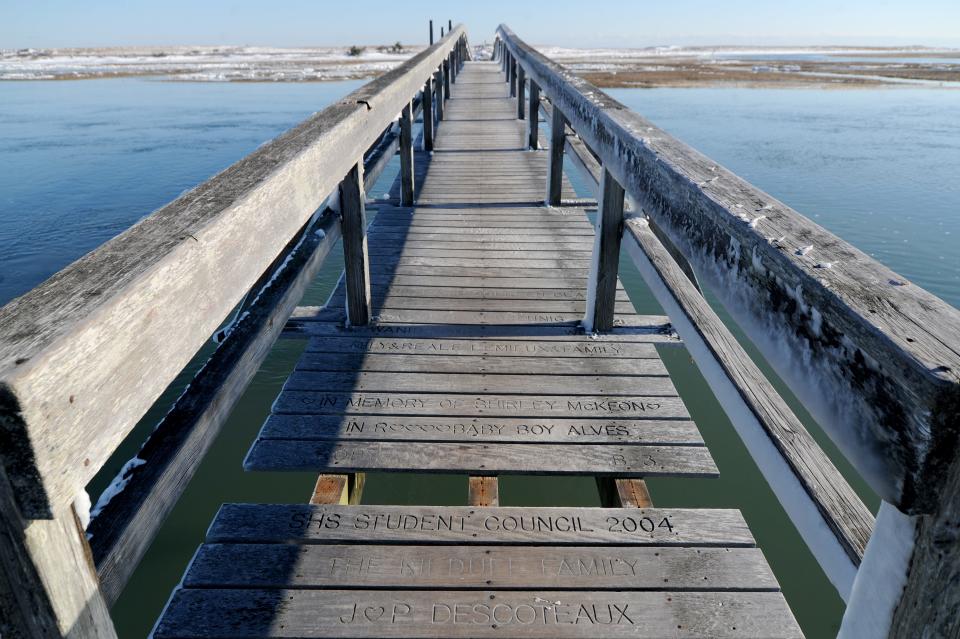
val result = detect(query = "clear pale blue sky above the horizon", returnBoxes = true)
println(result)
[0,0,960,48]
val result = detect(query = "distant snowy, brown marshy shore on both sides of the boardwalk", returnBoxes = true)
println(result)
[0,45,960,87]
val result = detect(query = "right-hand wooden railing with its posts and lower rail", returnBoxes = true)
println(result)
[495,25,960,636]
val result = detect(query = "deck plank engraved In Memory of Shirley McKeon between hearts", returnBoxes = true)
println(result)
[274,391,689,419]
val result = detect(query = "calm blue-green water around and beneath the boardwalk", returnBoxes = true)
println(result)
[0,79,960,638]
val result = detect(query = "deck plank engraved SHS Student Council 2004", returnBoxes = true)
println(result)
[207,504,754,547]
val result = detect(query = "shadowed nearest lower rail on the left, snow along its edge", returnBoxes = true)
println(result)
[88,215,340,604]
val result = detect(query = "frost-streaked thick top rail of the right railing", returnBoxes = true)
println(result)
[498,25,960,513]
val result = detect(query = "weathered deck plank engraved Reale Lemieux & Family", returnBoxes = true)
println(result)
[306,338,659,359]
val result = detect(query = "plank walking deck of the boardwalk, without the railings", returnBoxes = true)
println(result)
[155,62,800,638]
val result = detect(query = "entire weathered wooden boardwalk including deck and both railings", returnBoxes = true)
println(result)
[0,20,960,639]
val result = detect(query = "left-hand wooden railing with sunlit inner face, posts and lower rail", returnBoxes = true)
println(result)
[0,27,469,637]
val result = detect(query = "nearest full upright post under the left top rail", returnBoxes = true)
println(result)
[340,162,370,326]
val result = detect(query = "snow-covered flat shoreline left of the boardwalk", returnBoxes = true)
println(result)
[0,46,421,82]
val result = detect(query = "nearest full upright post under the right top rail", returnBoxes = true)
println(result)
[583,167,623,333]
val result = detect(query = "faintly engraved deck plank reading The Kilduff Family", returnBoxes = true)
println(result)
[183,544,779,592]
